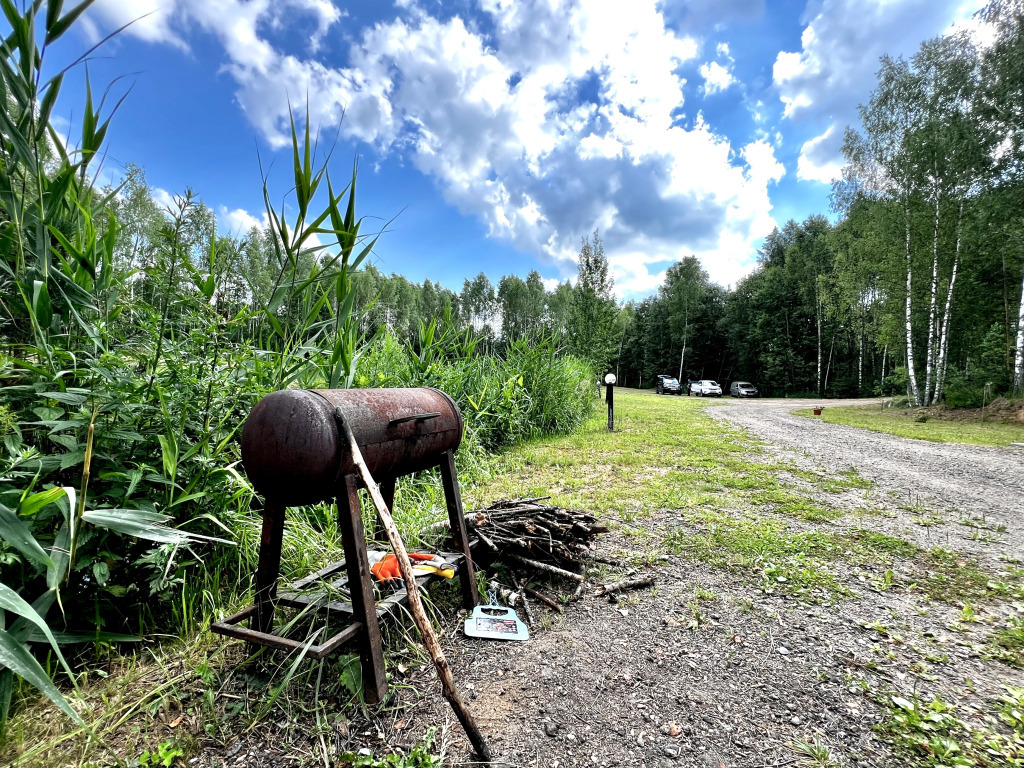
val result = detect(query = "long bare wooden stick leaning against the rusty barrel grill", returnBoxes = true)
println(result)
[335,409,490,763]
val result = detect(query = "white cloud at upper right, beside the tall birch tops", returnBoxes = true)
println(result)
[773,0,983,182]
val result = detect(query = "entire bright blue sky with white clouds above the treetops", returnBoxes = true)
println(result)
[51,0,982,298]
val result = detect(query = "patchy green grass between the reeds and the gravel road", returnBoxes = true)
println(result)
[465,389,1020,604]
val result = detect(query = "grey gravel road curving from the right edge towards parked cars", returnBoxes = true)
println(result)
[708,399,1024,560]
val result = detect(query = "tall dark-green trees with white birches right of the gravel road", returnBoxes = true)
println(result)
[616,0,1024,406]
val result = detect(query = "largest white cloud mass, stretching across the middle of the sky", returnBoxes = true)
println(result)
[92,0,783,295]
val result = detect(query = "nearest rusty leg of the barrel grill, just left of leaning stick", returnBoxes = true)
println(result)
[338,475,387,705]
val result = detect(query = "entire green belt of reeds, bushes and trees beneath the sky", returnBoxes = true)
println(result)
[0,0,1024,753]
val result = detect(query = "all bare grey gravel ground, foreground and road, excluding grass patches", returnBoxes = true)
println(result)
[378,400,1024,768]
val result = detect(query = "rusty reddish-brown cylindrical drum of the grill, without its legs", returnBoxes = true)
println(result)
[242,387,463,507]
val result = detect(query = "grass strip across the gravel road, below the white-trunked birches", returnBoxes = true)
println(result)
[794,406,1024,445]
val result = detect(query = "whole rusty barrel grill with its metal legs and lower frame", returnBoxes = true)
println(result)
[212,387,476,701]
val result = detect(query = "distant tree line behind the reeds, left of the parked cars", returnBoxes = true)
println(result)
[106,164,621,368]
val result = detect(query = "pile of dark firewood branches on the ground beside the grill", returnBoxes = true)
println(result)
[469,497,608,569]
